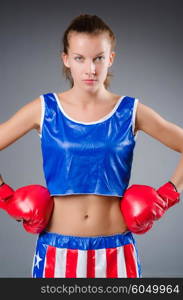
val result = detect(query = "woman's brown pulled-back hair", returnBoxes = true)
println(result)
[62,14,116,89]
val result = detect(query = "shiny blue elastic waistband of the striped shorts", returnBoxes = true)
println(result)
[38,231,135,250]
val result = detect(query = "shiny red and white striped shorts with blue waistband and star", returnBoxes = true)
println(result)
[32,231,141,278]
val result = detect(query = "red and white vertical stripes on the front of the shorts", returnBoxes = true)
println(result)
[43,244,139,278]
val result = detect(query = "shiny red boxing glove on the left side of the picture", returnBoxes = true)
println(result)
[0,183,54,233]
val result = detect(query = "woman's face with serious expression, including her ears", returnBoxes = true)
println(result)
[62,32,115,90]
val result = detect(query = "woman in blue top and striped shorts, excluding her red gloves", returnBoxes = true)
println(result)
[0,15,183,277]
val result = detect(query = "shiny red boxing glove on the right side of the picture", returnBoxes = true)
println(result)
[120,182,180,234]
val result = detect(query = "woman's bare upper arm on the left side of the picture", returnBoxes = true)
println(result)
[0,98,41,150]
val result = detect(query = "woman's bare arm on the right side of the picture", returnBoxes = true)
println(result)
[136,102,183,193]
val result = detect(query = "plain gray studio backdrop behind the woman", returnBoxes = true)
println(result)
[0,0,183,277]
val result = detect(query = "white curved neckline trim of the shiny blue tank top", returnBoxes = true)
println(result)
[53,93,126,125]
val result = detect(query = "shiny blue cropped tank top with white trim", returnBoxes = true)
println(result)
[40,93,138,197]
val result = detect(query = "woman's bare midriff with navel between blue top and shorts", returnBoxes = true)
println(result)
[45,194,127,236]
